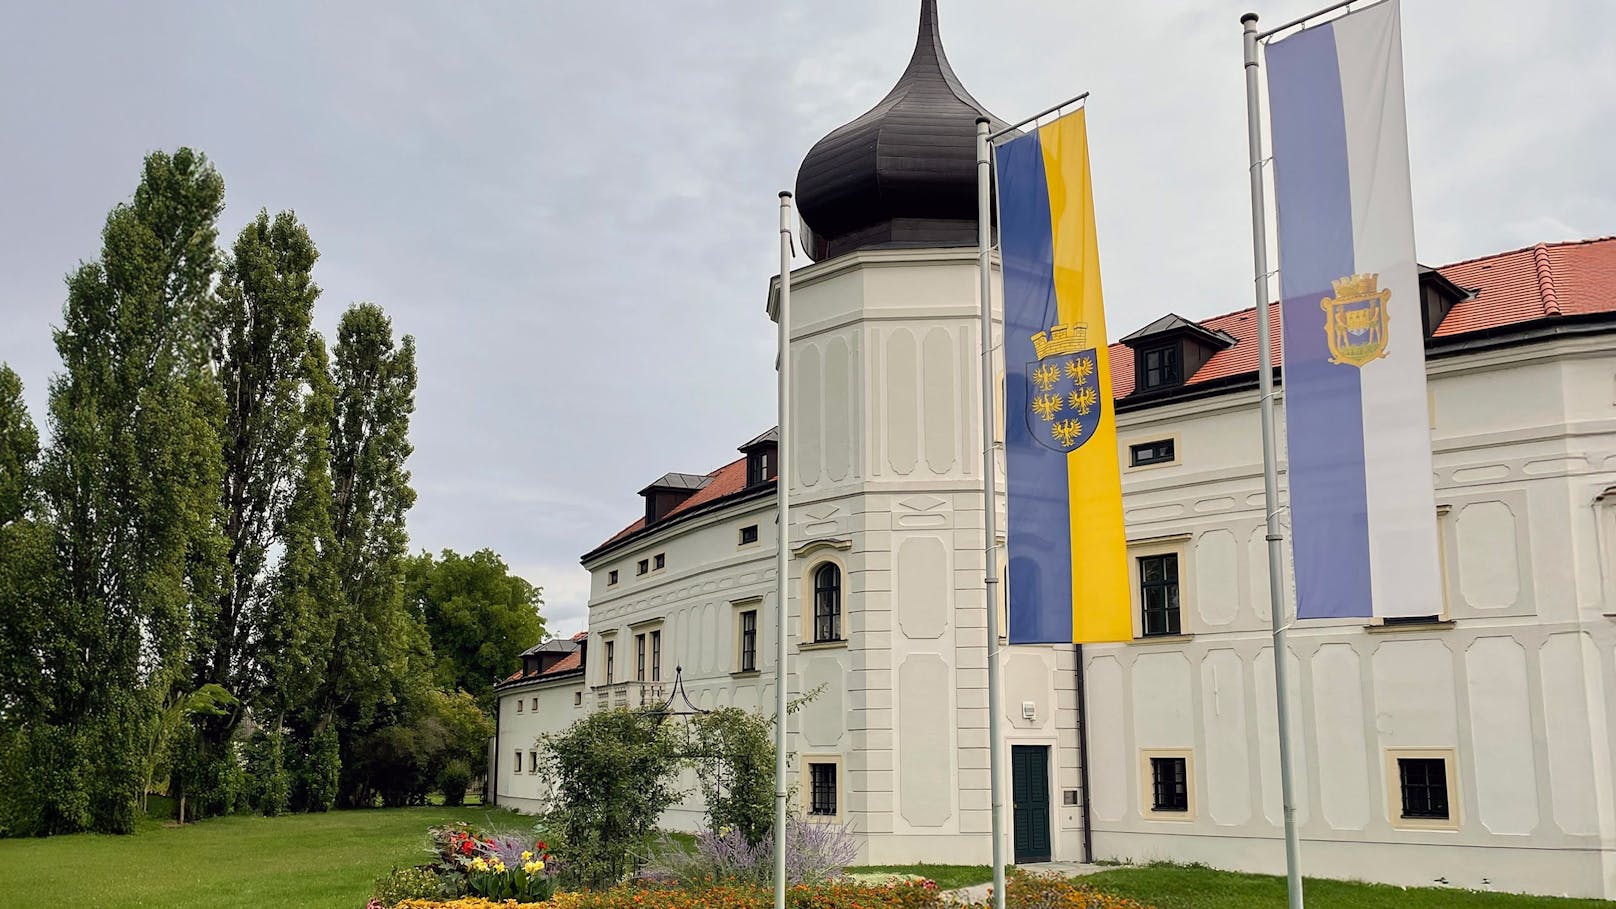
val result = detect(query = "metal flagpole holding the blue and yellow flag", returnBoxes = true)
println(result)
[976,118,1005,909]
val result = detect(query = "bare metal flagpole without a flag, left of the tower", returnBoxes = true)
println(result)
[774,186,792,909]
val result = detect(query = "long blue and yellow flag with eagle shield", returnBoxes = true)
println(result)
[995,110,1133,644]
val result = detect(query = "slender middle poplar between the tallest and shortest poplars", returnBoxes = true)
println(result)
[185,212,326,799]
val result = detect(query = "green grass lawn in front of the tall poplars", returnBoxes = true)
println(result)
[0,807,533,909]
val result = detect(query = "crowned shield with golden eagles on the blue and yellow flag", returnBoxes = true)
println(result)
[1026,323,1102,453]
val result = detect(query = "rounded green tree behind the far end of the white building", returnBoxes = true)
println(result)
[406,550,545,710]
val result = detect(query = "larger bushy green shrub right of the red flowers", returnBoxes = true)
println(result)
[540,708,680,886]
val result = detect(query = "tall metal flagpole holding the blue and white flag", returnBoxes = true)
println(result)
[1239,13,1302,909]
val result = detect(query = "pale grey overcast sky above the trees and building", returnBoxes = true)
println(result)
[0,0,1616,634]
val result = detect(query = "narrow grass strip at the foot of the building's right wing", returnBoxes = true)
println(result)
[1081,865,1613,909]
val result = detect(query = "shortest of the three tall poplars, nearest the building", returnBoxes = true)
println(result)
[320,302,431,801]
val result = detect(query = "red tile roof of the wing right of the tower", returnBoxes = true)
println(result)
[1110,236,1616,398]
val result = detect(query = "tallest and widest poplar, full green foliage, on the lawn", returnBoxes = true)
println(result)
[40,149,225,833]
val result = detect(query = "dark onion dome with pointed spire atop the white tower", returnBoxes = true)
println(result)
[797,0,1005,259]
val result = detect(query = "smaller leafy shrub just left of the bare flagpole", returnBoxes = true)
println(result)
[687,707,774,843]
